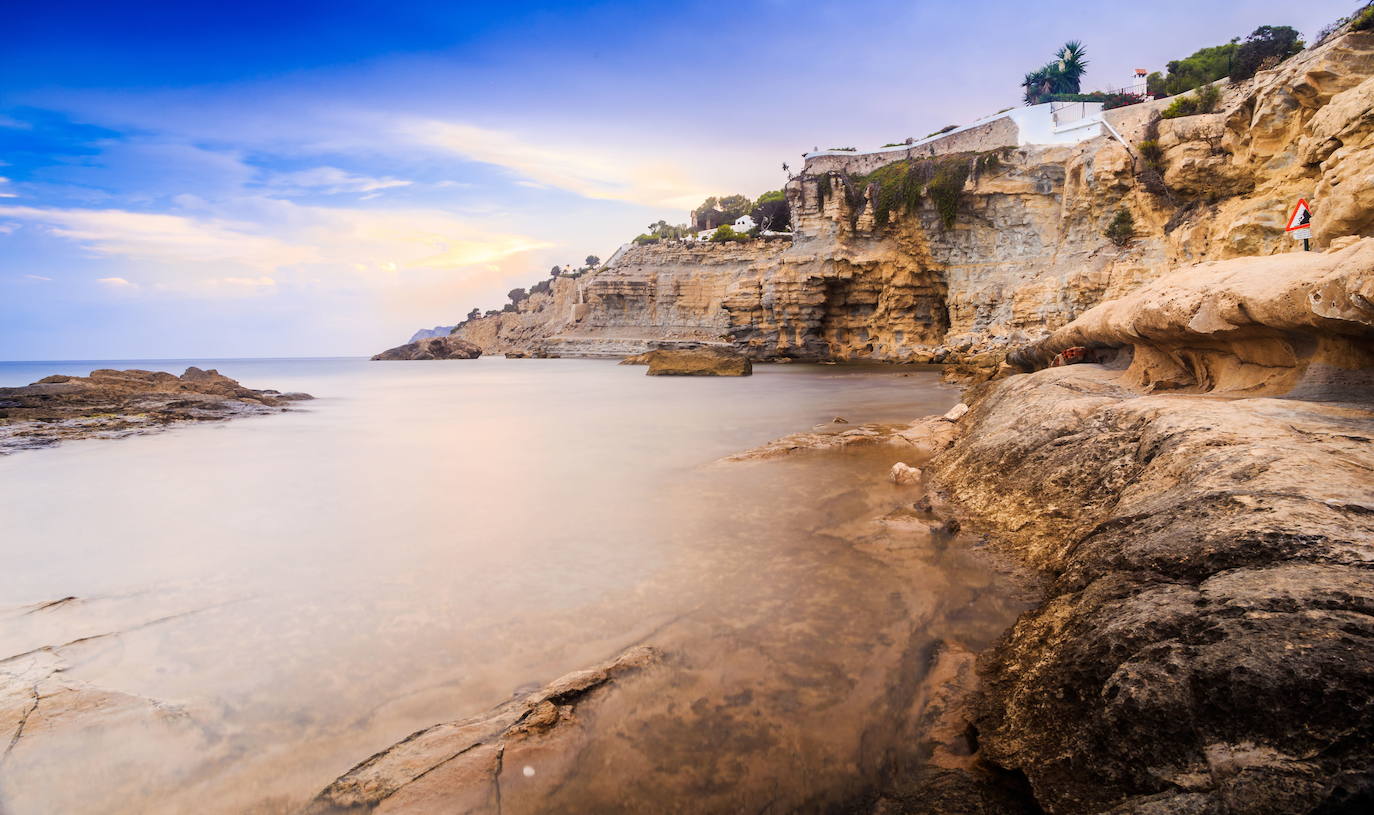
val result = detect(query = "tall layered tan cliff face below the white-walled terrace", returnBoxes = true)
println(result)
[442,33,1374,360]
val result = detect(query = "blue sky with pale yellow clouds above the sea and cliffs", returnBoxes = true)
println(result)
[0,0,1359,360]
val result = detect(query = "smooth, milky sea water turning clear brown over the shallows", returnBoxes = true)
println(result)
[0,359,1022,815]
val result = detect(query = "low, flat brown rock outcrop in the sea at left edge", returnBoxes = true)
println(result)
[0,367,312,455]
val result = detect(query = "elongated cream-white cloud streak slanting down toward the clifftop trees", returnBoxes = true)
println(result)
[394,118,709,208]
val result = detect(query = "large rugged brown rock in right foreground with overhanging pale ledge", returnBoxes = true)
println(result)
[927,241,1374,815]
